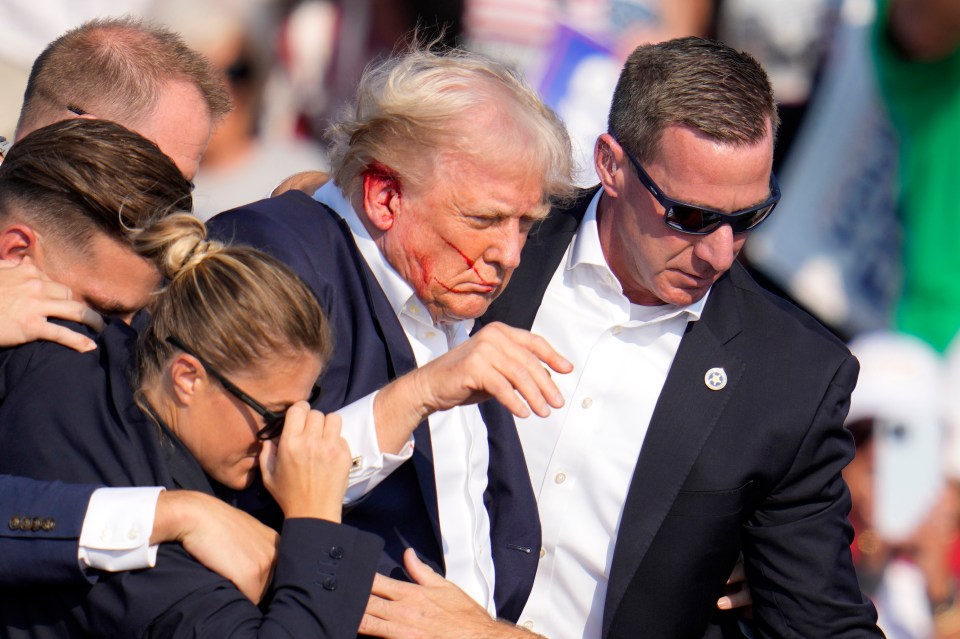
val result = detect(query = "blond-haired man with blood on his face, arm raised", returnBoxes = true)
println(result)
[209,49,571,620]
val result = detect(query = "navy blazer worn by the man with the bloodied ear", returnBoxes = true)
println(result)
[208,191,540,621]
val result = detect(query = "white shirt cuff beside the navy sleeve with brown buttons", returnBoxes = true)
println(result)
[78,486,163,572]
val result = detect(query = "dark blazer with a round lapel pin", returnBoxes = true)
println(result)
[483,190,882,639]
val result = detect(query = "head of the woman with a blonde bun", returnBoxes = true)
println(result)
[135,214,331,489]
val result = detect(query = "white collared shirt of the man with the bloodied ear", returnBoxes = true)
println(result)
[314,182,495,614]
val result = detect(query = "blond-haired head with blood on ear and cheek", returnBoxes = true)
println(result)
[330,48,572,321]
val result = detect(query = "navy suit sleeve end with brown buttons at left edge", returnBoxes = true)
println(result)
[0,475,97,586]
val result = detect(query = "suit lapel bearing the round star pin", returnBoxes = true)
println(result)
[602,267,744,637]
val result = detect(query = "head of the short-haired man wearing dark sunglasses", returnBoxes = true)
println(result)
[594,38,779,305]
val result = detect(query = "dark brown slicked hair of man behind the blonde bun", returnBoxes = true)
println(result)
[0,118,193,251]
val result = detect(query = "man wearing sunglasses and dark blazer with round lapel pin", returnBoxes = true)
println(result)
[361,38,882,639]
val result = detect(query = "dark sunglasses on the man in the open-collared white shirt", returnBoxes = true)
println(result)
[621,145,780,235]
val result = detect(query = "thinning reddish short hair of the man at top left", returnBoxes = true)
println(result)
[17,17,230,132]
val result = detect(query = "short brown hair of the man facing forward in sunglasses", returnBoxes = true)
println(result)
[608,37,780,163]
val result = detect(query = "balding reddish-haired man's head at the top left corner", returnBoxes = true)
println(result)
[16,18,230,180]
